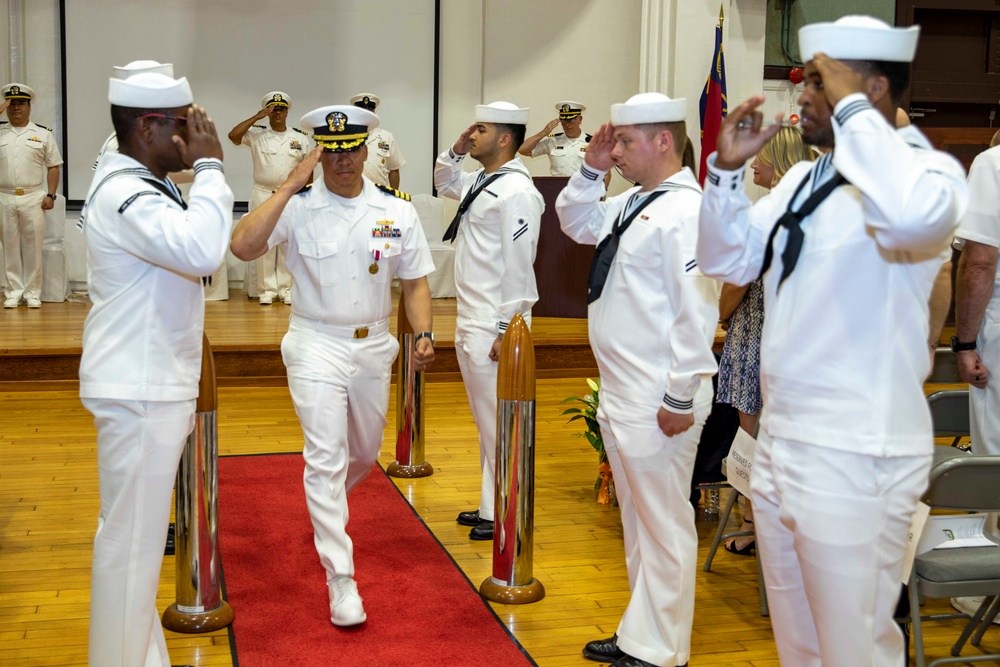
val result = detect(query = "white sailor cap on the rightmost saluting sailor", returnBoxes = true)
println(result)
[799,16,920,63]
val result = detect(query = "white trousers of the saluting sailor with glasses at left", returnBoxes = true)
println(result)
[82,398,195,667]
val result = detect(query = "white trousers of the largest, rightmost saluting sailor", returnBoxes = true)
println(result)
[750,430,931,667]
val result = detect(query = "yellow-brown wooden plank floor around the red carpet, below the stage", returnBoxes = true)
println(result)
[0,379,1000,667]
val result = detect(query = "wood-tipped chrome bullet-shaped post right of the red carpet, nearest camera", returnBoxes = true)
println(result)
[479,315,545,604]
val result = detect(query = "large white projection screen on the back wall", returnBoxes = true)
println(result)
[63,0,435,202]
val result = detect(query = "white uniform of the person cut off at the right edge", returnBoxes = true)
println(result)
[958,147,1000,455]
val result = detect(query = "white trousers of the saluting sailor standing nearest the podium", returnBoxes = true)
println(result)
[455,317,516,521]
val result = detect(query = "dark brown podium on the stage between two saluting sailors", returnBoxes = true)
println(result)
[531,176,594,318]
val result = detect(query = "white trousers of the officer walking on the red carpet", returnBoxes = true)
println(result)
[281,319,399,582]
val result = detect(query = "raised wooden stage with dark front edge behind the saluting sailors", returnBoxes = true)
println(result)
[0,290,597,391]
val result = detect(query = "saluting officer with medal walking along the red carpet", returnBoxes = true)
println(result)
[231,105,442,626]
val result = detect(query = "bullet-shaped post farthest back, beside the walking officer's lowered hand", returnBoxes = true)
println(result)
[385,295,434,477]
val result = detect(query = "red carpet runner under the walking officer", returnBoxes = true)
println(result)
[219,454,535,667]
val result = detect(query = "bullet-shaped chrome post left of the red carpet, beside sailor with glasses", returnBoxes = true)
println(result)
[163,335,233,632]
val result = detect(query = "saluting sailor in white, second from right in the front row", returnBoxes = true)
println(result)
[556,93,719,667]
